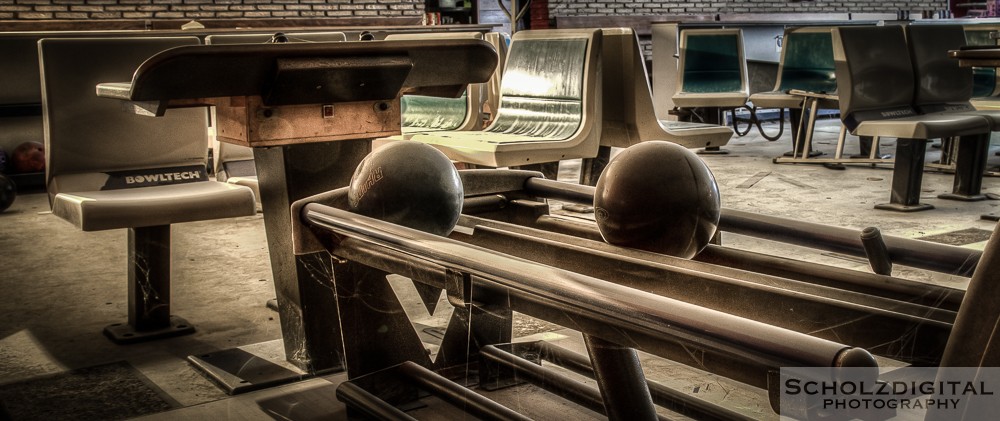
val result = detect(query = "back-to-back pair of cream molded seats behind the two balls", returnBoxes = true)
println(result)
[376,28,733,184]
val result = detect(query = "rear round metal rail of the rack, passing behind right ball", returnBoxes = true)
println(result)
[524,178,982,276]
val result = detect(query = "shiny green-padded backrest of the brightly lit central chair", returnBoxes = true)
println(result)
[485,29,601,140]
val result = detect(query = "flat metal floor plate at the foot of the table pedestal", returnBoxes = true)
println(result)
[188,340,317,395]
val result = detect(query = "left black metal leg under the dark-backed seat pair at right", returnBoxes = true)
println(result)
[875,139,934,212]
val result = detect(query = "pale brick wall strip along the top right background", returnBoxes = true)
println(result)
[548,0,948,17]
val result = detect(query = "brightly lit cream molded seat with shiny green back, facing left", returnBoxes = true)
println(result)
[398,29,601,167]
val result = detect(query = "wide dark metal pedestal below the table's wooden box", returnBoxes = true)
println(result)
[253,139,371,372]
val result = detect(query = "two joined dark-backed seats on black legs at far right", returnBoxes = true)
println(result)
[833,25,996,211]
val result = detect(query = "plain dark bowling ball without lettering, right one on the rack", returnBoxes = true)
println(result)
[594,141,721,259]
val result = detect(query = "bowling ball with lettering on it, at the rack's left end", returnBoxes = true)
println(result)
[347,141,464,236]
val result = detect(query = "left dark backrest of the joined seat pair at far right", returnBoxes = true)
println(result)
[833,25,917,131]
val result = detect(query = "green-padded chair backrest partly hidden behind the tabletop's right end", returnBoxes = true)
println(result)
[385,32,485,132]
